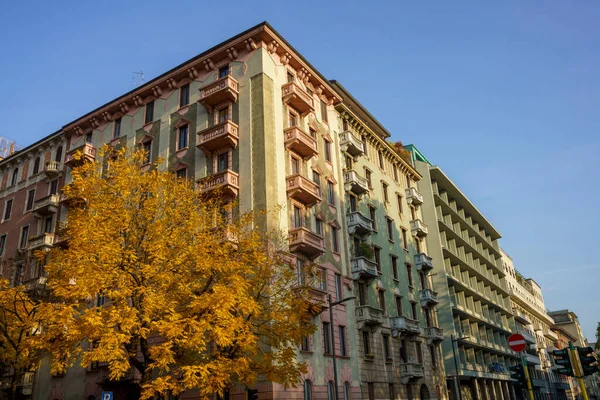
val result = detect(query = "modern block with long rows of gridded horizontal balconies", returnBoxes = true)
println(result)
[408,146,518,399]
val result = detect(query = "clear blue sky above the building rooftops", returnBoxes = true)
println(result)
[0,0,600,340]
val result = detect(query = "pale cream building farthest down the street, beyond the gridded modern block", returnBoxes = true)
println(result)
[500,249,576,400]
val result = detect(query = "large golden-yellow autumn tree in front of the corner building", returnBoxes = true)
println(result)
[42,148,314,399]
